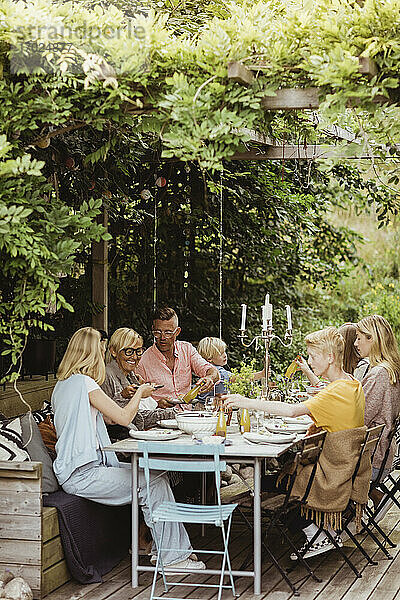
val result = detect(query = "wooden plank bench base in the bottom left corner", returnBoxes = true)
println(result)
[0,461,71,599]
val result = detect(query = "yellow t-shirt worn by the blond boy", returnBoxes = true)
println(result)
[304,379,365,431]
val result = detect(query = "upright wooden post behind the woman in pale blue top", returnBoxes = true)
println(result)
[92,208,108,331]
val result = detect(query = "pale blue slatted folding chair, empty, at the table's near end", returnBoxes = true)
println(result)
[138,442,237,600]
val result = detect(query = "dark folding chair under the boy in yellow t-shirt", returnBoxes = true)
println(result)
[231,431,326,596]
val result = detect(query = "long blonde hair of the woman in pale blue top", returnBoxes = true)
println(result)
[57,327,106,385]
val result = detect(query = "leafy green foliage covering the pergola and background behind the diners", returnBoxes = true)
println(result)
[0,0,400,377]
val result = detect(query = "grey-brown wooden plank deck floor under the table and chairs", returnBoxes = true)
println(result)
[46,508,400,600]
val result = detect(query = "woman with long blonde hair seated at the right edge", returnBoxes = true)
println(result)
[354,315,400,486]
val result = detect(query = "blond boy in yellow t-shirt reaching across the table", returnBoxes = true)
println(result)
[224,327,365,558]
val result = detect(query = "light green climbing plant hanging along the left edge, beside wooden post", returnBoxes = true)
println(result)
[0,135,109,380]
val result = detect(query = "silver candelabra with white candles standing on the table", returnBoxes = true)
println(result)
[238,294,293,400]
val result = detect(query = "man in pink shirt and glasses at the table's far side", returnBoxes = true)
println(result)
[136,307,219,403]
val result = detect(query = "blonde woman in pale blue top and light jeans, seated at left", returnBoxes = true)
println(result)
[52,327,205,569]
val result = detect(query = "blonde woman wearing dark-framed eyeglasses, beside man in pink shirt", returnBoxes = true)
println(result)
[101,327,175,437]
